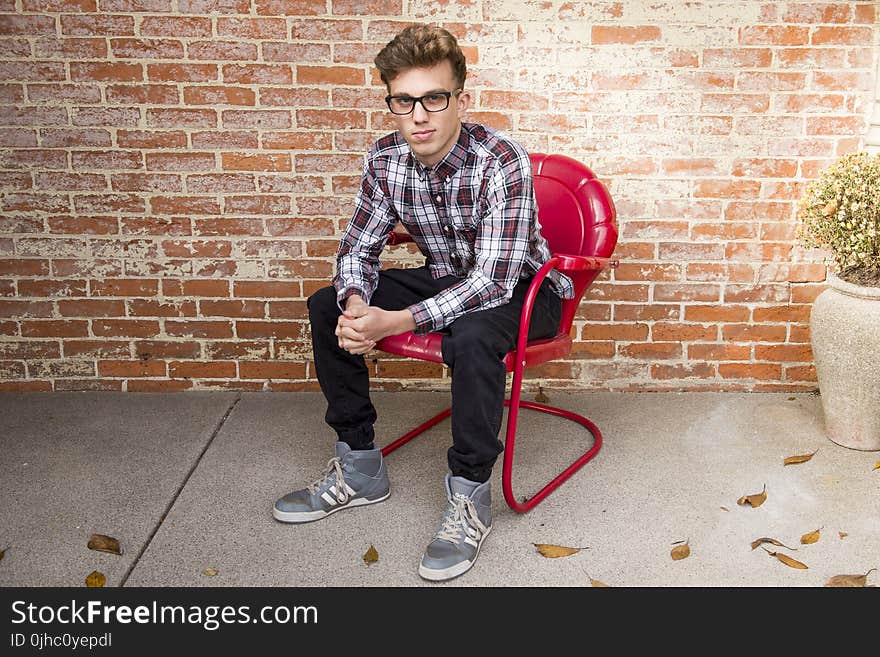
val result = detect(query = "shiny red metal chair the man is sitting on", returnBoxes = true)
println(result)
[376,153,617,513]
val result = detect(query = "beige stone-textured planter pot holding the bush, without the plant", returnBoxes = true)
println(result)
[810,272,880,451]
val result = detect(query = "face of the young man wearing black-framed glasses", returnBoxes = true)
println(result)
[388,59,470,167]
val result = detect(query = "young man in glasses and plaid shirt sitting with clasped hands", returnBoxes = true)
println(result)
[273,25,573,581]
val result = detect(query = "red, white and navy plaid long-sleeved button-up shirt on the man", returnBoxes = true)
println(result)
[333,123,574,334]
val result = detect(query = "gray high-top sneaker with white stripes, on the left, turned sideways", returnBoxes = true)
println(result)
[272,442,391,522]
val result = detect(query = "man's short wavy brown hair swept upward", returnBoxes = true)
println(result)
[373,24,467,89]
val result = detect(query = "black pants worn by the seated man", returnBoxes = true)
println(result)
[308,267,562,482]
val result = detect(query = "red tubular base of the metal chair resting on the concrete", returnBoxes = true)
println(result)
[381,387,602,513]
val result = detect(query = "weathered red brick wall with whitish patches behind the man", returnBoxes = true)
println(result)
[0,0,880,391]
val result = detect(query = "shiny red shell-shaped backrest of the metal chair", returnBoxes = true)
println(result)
[530,153,617,334]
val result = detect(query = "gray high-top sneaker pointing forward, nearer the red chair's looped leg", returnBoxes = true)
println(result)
[419,473,492,581]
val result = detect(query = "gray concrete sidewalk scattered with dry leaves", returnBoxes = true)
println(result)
[0,392,880,587]
